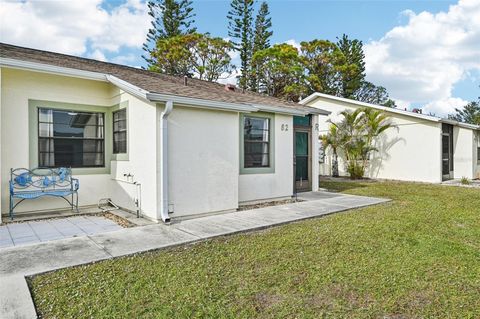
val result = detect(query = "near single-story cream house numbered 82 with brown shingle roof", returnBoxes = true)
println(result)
[0,44,329,222]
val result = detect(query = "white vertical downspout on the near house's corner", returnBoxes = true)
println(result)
[160,101,173,223]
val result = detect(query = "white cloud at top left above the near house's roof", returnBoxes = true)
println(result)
[0,0,150,57]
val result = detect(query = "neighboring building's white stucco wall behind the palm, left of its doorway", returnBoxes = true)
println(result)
[308,98,442,183]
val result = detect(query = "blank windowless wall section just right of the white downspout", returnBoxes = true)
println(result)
[168,105,239,218]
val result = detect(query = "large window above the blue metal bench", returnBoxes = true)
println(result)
[38,108,105,167]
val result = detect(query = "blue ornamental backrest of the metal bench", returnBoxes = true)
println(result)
[10,167,73,192]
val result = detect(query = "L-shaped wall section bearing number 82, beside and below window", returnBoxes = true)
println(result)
[237,114,293,203]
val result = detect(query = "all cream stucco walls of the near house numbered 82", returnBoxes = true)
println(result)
[0,68,310,224]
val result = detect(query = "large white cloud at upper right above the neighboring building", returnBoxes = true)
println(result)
[365,0,480,115]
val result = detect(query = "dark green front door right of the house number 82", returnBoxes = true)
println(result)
[295,130,311,191]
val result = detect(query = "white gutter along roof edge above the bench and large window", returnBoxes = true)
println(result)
[0,58,107,81]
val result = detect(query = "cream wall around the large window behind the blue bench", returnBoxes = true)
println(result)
[0,68,119,218]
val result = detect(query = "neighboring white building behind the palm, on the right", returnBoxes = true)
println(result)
[300,93,480,183]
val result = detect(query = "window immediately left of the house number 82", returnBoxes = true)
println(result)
[243,116,270,168]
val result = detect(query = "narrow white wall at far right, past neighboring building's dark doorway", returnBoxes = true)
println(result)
[453,126,477,179]
